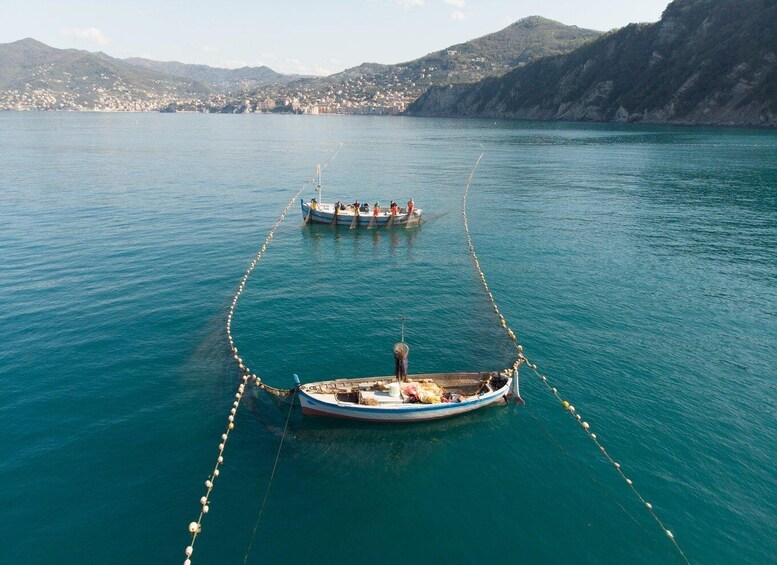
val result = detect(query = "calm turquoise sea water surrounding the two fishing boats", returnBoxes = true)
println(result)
[0,113,777,564]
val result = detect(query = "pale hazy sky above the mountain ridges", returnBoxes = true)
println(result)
[0,0,668,74]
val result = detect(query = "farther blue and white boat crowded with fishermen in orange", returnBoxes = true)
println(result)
[300,165,423,229]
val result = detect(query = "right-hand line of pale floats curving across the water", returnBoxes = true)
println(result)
[461,153,690,563]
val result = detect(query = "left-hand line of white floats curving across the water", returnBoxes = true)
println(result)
[184,143,343,565]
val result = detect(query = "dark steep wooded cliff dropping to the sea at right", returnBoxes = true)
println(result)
[407,0,777,127]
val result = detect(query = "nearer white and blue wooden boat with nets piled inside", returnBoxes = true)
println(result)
[296,367,520,422]
